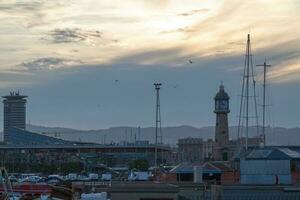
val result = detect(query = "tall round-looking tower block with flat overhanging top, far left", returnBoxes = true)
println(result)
[2,92,27,143]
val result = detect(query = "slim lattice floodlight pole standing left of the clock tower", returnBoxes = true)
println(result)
[154,83,162,170]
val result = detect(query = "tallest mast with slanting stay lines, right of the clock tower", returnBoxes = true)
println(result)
[238,34,258,150]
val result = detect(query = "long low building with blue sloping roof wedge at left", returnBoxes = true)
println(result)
[0,128,172,173]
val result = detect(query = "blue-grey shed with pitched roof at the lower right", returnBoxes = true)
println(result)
[236,147,300,185]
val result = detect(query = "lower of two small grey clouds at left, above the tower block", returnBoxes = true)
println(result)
[19,57,82,71]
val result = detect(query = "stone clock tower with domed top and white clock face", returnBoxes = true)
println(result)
[214,84,230,161]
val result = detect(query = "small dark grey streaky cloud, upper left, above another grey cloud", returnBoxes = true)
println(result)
[43,28,102,43]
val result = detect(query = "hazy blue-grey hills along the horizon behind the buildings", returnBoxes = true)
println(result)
[27,125,300,145]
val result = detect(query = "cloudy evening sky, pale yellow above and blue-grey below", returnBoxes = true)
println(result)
[0,0,300,129]
